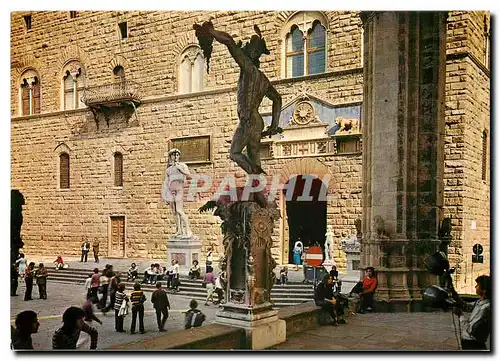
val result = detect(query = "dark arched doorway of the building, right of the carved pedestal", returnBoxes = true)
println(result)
[283,175,327,264]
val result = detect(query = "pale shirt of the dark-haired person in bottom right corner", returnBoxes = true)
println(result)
[460,299,491,342]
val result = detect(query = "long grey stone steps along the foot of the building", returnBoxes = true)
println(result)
[48,268,314,308]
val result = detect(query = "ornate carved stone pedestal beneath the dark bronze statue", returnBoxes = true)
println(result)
[216,202,286,349]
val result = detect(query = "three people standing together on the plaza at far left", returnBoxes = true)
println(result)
[10,253,48,301]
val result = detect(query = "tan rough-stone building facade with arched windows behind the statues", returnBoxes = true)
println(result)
[11,11,490,288]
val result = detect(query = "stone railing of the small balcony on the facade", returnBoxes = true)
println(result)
[82,81,141,107]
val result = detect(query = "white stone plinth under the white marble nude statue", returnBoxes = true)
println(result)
[167,235,201,273]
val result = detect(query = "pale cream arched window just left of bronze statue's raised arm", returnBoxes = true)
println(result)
[179,45,205,94]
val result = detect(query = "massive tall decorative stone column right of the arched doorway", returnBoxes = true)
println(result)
[361,12,446,310]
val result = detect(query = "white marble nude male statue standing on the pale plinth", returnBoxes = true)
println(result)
[161,148,192,238]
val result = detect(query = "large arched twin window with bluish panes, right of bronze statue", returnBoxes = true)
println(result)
[283,12,327,78]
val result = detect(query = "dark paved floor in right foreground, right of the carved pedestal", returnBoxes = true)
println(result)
[273,312,458,351]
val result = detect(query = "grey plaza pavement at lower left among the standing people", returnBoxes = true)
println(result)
[10,282,217,350]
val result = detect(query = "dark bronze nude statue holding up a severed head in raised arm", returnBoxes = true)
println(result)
[193,21,282,174]
